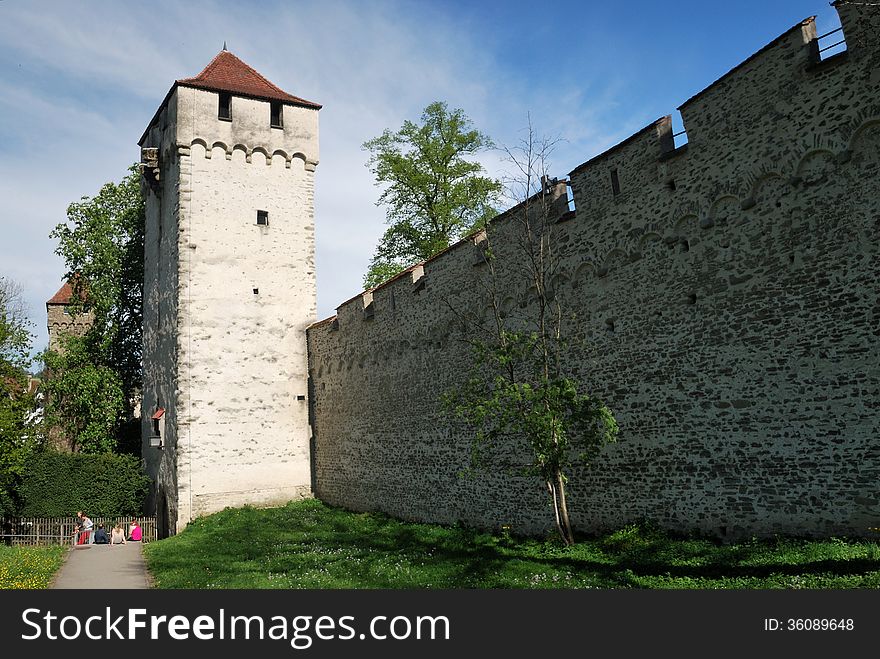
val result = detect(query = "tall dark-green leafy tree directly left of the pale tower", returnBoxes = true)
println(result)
[44,165,145,451]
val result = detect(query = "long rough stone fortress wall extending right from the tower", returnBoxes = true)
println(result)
[308,4,880,538]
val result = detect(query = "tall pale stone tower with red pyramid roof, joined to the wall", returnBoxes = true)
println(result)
[139,48,321,535]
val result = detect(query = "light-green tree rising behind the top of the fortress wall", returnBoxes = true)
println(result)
[364,101,501,288]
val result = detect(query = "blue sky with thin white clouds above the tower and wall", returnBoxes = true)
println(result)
[0,0,839,360]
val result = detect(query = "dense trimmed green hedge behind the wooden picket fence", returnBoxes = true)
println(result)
[18,451,150,517]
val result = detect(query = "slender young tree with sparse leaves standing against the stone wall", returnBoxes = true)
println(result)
[444,127,618,545]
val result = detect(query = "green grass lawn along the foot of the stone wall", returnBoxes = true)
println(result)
[144,500,880,588]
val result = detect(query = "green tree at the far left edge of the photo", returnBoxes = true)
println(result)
[0,277,40,513]
